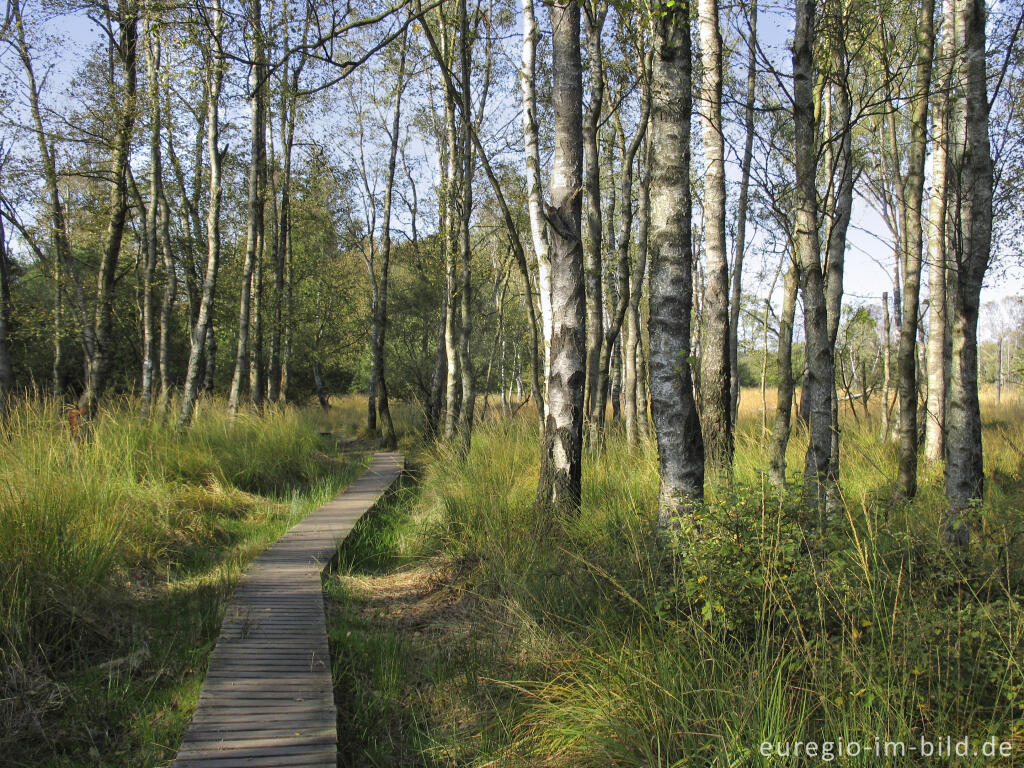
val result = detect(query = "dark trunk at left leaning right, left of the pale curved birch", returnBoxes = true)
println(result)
[78,0,138,412]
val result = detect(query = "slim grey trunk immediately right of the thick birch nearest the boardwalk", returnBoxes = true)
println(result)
[583,0,608,443]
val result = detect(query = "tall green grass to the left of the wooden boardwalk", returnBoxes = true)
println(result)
[0,400,368,768]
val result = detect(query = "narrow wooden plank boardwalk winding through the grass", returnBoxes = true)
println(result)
[172,453,404,768]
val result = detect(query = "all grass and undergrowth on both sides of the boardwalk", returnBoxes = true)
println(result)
[0,392,1024,767]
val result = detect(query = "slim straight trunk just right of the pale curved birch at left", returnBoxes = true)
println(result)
[227,7,266,415]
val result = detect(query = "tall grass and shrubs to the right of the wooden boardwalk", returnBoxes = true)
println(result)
[329,391,1024,768]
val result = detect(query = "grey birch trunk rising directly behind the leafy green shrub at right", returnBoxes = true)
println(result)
[793,0,838,512]
